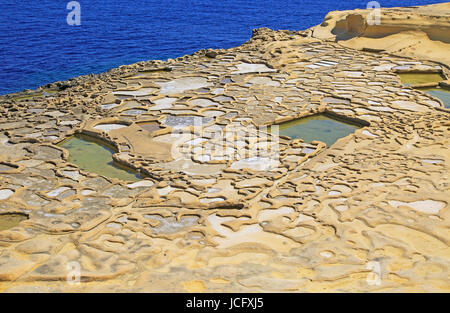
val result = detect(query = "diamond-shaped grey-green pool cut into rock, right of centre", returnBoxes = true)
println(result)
[269,114,361,147]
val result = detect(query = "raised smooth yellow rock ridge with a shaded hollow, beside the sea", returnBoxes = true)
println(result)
[310,2,450,67]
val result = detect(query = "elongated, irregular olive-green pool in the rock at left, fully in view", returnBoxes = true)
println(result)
[59,135,142,181]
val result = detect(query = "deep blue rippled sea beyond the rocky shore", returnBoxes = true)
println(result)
[0,0,445,94]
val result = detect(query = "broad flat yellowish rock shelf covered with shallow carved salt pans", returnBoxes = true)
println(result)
[0,3,450,292]
